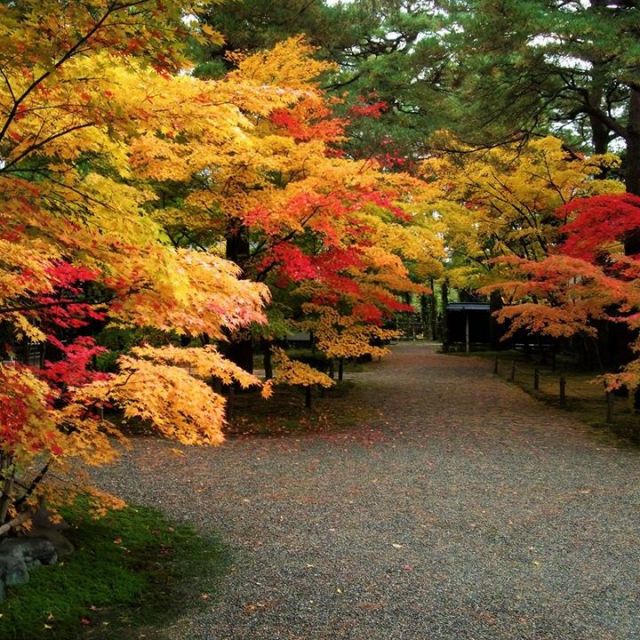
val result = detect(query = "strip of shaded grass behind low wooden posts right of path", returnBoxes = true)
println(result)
[452,351,640,444]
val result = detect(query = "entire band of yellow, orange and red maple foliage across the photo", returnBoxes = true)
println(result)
[0,0,640,523]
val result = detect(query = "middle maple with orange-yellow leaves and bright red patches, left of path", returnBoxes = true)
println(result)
[158,38,442,366]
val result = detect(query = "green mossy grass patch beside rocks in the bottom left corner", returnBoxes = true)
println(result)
[0,501,229,640]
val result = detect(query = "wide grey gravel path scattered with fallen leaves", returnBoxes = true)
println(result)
[94,344,640,640]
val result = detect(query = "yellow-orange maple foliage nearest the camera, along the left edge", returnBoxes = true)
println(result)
[0,0,268,524]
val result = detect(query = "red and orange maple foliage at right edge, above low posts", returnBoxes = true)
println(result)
[486,193,640,389]
